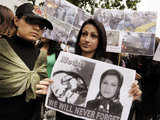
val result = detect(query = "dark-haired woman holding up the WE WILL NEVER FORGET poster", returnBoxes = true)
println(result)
[37,19,141,120]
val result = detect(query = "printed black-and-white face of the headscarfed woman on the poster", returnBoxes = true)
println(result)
[101,75,118,98]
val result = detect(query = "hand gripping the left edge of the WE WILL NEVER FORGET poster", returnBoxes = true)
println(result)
[36,78,53,95]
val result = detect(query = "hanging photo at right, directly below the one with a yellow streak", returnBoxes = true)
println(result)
[122,32,155,56]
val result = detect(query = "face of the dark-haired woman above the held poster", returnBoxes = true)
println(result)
[79,24,99,53]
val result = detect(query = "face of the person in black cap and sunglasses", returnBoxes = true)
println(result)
[14,17,44,41]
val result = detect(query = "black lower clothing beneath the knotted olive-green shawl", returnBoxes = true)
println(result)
[0,94,41,120]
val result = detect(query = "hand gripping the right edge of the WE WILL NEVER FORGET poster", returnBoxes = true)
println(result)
[129,81,142,100]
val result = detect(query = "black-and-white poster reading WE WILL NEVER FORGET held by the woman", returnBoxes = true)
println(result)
[45,52,136,120]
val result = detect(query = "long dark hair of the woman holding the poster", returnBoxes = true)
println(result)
[75,18,107,59]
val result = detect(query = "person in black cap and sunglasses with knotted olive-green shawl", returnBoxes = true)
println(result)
[0,3,52,120]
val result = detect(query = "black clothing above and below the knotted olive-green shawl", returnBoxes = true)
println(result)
[0,36,41,120]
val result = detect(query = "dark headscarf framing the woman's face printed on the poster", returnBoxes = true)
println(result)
[100,69,123,99]
